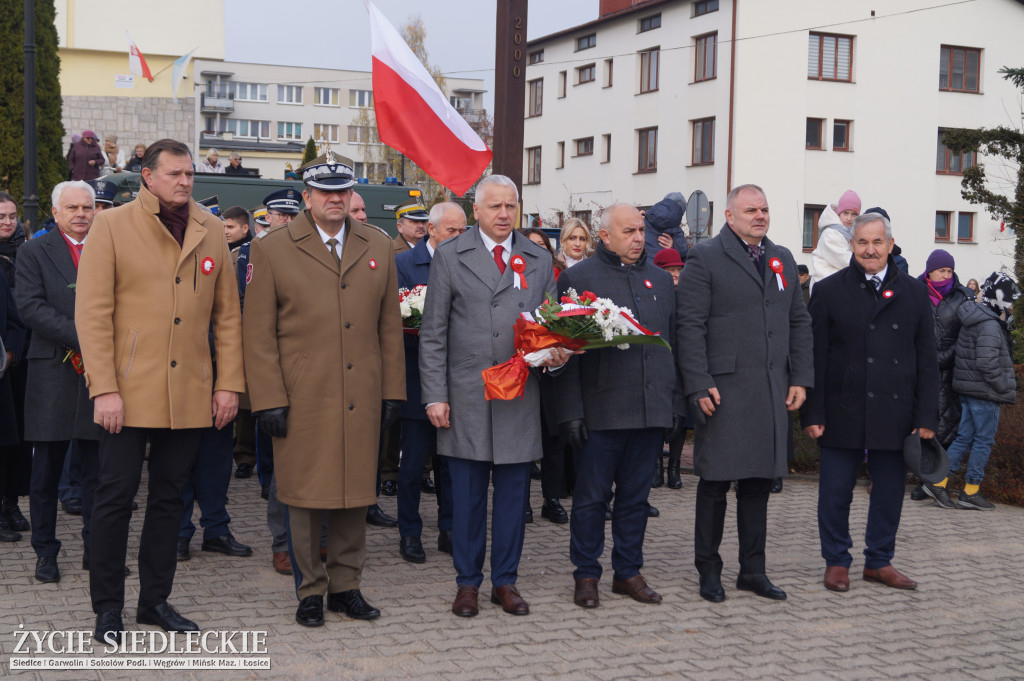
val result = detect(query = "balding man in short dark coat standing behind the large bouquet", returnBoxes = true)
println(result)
[555,204,683,607]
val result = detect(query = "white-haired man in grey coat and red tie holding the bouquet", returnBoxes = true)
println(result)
[420,175,568,618]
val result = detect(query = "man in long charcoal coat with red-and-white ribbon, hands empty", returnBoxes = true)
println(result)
[677,184,814,602]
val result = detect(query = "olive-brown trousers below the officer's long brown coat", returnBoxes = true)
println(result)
[288,506,367,600]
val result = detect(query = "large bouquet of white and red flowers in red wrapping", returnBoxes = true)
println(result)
[482,289,670,399]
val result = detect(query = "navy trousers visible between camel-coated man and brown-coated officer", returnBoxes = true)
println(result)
[178,424,233,540]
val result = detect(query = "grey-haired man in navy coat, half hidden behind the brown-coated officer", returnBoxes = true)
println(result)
[394,202,466,563]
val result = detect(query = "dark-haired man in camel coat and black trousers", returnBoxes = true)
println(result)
[75,139,245,641]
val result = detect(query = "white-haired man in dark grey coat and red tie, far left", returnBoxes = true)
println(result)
[14,180,100,583]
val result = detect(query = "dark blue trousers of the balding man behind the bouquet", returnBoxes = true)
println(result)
[569,428,665,580]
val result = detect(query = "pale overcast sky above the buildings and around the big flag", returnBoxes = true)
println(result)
[224,0,598,113]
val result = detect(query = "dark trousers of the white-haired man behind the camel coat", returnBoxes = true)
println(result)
[29,440,99,558]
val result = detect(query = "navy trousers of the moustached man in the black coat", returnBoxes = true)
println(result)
[818,446,906,569]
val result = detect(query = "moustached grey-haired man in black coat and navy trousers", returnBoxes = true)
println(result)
[801,213,939,591]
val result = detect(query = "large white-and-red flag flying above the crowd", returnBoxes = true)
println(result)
[364,0,494,197]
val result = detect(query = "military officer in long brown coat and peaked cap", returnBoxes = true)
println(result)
[243,152,406,627]
